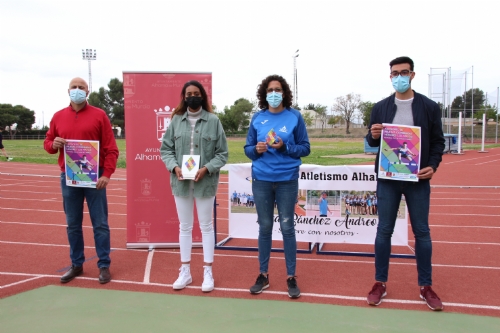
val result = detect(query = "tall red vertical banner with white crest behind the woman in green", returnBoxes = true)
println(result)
[123,72,212,248]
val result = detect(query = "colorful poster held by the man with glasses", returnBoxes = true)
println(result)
[378,124,420,182]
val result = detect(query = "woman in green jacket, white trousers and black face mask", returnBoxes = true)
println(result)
[160,80,228,292]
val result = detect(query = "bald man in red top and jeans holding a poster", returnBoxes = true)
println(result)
[44,78,119,283]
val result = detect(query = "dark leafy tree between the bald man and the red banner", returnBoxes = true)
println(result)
[88,78,125,128]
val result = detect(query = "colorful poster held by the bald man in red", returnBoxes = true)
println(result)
[64,140,99,188]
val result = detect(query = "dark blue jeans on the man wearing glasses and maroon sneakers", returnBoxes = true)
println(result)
[375,179,432,286]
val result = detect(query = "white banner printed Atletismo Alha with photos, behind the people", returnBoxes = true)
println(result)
[227,163,408,246]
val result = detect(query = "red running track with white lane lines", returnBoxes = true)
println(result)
[0,148,500,317]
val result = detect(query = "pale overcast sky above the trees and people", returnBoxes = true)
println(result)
[0,0,500,126]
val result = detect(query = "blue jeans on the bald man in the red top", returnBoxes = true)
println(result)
[61,172,111,268]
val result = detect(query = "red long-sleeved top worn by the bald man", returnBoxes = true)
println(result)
[43,103,119,178]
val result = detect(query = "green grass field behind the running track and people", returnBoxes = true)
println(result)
[1,138,500,168]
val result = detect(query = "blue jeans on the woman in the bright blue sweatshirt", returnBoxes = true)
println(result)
[252,179,299,276]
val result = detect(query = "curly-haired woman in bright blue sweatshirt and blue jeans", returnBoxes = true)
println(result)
[244,75,310,298]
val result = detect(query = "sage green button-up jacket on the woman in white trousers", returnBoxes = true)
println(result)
[160,110,228,198]
